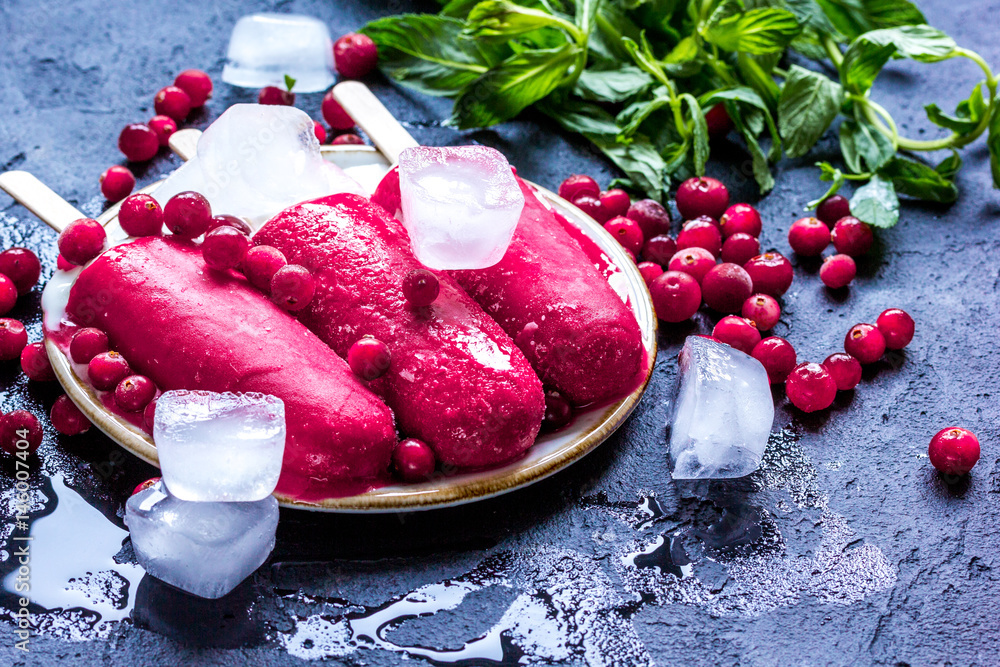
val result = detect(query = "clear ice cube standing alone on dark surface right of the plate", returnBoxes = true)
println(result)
[670,336,774,479]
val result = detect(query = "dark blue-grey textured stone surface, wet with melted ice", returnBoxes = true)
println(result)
[0,0,1000,667]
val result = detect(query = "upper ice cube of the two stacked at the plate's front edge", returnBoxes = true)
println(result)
[153,391,285,502]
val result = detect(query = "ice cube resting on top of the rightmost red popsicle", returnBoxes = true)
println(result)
[399,146,524,269]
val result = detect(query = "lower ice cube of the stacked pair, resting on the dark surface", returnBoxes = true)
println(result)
[125,480,278,599]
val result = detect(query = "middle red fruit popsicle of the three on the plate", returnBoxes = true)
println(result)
[254,194,544,468]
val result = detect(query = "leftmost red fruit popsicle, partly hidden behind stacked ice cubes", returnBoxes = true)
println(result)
[61,237,396,498]
